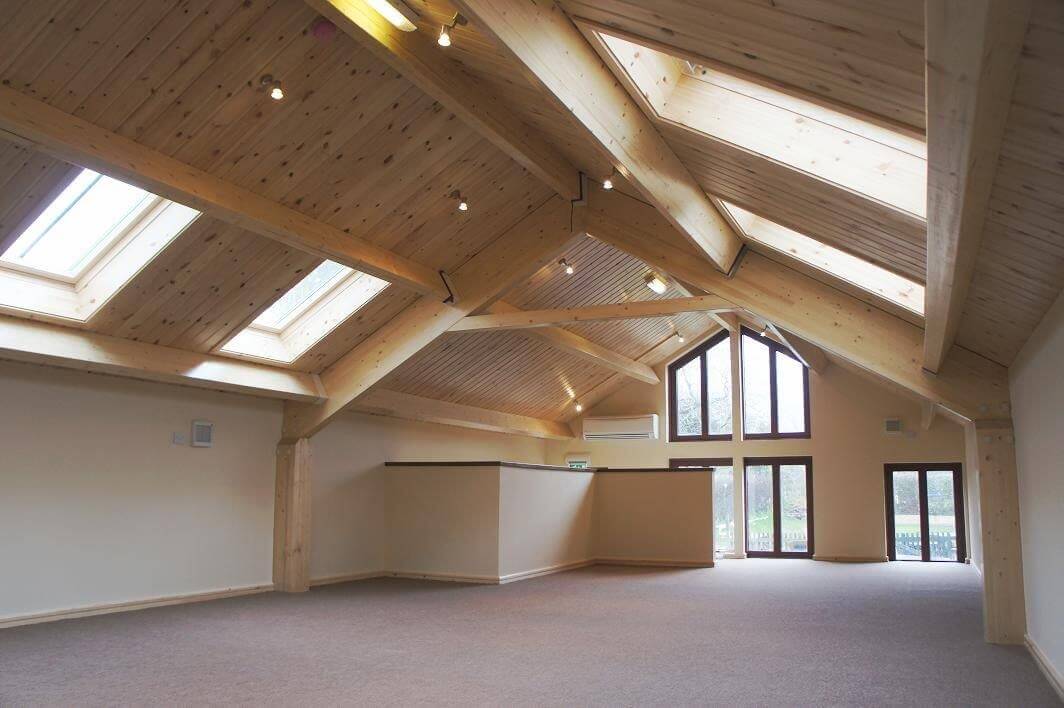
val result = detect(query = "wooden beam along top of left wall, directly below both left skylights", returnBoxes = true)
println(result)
[0,315,325,406]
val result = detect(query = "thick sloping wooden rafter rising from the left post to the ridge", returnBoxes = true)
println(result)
[282,197,582,442]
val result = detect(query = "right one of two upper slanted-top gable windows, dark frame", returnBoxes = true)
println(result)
[742,328,810,440]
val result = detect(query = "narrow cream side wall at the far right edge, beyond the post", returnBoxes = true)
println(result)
[1009,295,1064,682]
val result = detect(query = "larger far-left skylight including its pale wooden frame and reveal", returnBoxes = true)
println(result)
[0,167,199,324]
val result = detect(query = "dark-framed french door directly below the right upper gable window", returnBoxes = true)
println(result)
[743,457,813,558]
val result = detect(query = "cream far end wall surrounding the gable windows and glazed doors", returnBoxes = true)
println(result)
[548,355,964,558]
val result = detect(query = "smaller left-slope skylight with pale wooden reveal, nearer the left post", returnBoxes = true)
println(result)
[220,261,388,364]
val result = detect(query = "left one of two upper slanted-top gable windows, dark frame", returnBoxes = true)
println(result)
[668,331,732,442]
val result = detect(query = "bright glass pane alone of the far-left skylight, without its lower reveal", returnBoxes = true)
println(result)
[2,169,160,278]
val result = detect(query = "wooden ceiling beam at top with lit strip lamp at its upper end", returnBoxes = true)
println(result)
[306,0,580,200]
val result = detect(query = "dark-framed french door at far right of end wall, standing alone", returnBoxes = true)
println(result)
[884,463,966,563]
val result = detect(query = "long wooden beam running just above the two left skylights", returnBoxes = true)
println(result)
[0,86,450,300]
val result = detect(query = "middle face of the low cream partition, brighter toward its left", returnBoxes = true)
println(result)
[499,467,596,577]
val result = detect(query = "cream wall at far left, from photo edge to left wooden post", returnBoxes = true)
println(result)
[0,363,281,618]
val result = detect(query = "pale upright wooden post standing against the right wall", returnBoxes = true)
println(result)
[965,419,1027,644]
